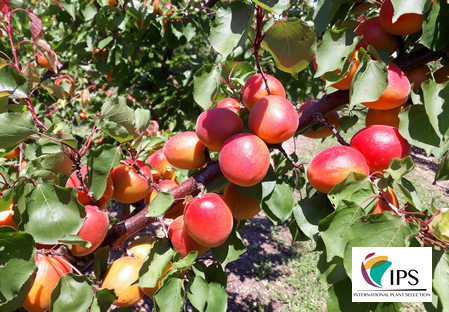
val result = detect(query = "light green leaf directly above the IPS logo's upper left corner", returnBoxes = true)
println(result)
[319,200,364,262]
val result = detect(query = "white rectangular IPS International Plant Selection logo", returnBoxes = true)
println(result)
[352,247,432,302]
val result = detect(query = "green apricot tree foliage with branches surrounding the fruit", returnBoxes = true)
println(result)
[0,0,449,311]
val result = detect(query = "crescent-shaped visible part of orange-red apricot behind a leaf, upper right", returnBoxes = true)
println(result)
[362,62,411,110]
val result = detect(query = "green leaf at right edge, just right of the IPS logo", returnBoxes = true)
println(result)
[432,250,449,310]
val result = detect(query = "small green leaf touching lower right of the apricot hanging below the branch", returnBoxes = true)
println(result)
[211,224,246,268]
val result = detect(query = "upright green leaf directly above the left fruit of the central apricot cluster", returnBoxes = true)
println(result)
[193,64,221,110]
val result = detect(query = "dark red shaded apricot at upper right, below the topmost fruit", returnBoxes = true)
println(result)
[354,16,398,55]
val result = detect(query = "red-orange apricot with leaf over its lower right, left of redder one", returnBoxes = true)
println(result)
[307,146,369,194]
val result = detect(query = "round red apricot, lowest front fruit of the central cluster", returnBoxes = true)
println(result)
[218,133,271,186]
